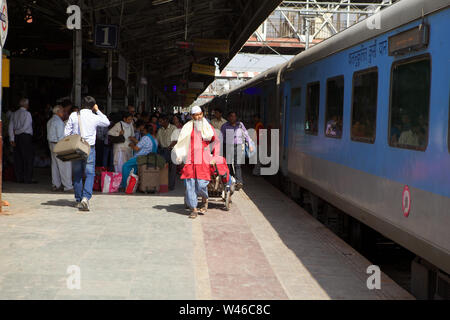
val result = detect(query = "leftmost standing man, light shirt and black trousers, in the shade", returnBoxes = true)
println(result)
[8,98,36,183]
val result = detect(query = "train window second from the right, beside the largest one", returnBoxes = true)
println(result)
[351,68,378,143]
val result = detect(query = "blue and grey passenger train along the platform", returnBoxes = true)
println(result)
[205,0,450,298]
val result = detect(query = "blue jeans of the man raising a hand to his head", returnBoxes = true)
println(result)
[72,146,95,202]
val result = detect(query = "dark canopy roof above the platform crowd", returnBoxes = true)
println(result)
[8,0,281,103]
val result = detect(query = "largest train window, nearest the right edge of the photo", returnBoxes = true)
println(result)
[389,56,431,151]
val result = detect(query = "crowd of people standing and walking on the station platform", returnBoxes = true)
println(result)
[2,96,262,218]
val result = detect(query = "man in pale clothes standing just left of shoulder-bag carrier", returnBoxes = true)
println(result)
[47,105,73,191]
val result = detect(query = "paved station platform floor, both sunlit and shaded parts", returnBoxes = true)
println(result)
[0,170,412,299]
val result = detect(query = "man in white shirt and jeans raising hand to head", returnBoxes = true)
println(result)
[64,96,109,211]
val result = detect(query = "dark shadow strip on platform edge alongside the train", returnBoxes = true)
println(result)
[239,170,411,299]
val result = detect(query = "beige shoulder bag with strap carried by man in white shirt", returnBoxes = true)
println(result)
[53,112,91,161]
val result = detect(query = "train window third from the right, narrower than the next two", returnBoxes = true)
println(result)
[325,76,344,138]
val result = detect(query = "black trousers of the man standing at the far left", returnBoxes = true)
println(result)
[14,133,34,183]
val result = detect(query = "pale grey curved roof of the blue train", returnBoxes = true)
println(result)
[212,0,450,100]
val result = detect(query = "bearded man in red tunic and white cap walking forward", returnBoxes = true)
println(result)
[172,106,220,219]
